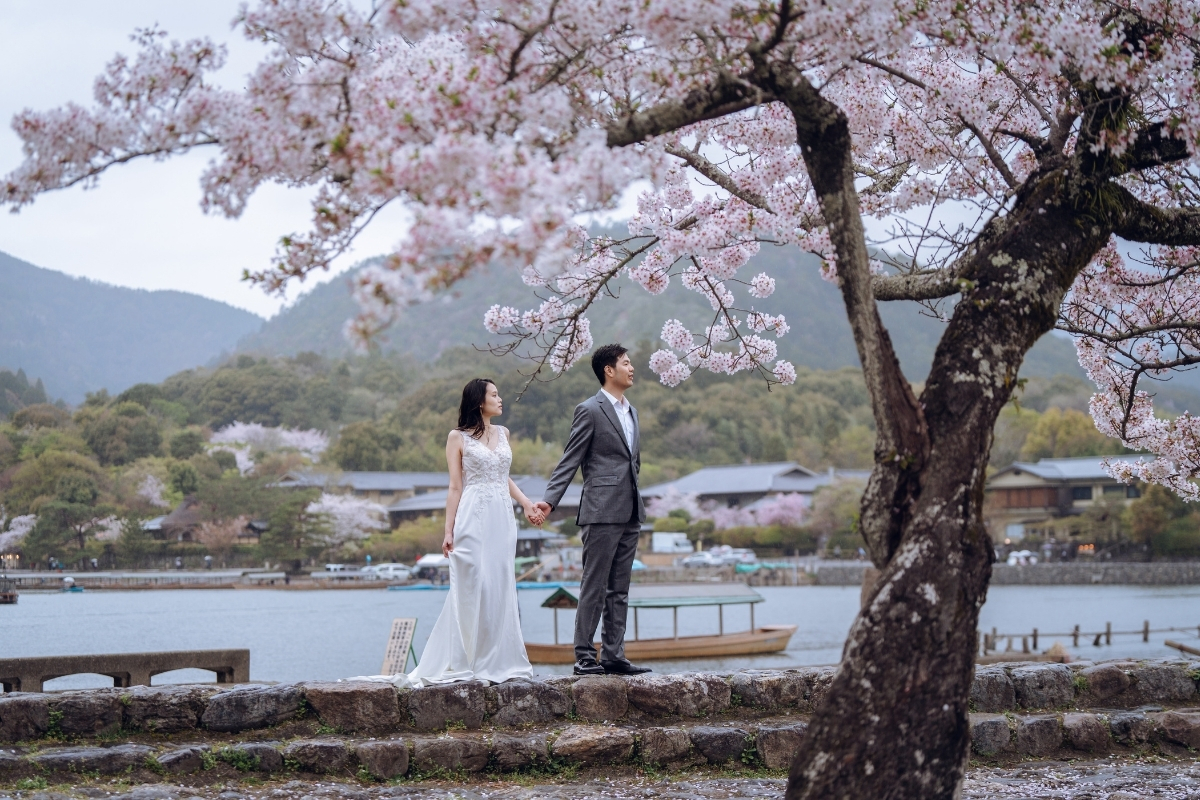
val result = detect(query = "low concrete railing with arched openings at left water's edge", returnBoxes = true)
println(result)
[0,650,250,692]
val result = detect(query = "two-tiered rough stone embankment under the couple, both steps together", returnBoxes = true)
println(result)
[0,661,1200,786]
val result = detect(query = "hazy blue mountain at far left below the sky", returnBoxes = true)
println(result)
[0,253,263,403]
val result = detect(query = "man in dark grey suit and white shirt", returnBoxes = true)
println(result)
[536,344,650,675]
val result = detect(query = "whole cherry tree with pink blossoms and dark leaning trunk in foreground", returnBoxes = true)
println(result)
[2,0,1200,798]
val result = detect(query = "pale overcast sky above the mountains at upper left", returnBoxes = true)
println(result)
[0,0,403,317]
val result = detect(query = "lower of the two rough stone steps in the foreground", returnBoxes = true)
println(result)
[0,708,1200,784]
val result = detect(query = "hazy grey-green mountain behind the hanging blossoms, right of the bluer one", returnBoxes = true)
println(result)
[238,247,1084,380]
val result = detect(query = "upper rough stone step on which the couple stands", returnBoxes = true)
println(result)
[0,661,1200,742]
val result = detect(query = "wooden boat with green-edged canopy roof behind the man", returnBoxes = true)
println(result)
[526,583,796,664]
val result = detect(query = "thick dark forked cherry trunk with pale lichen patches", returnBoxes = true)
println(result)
[787,113,1111,800]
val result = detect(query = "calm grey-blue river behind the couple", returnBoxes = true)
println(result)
[0,587,1200,688]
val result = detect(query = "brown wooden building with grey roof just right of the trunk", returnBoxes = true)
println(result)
[984,456,1148,543]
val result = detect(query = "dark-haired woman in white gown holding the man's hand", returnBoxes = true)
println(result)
[404,378,545,686]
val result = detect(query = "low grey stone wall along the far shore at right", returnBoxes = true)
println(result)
[812,561,1200,587]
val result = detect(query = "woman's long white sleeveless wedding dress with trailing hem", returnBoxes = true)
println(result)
[355,432,533,687]
